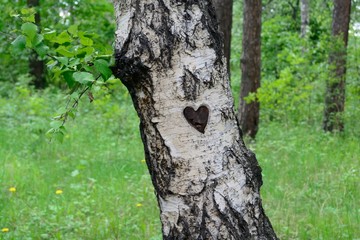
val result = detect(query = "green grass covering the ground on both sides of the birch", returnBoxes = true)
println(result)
[0,82,360,240]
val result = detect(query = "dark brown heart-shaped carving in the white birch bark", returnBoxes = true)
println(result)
[183,106,209,133]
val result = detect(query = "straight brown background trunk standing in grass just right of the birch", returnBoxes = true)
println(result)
[239,0,261,138]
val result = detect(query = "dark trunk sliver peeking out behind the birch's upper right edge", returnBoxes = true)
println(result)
[212,0,233,71]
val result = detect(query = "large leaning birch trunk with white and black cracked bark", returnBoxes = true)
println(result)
[113,0,276,240]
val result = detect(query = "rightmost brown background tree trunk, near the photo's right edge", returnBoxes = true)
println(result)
[323,0,351,132]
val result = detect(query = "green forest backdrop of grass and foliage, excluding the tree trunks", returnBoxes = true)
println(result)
[0,0,360,239]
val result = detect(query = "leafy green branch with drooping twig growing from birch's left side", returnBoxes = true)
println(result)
[8,5,112,141]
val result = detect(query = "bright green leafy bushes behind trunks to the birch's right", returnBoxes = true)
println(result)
[232,2,359,126]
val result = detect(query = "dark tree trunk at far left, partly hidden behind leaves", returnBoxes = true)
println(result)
[27,0,47,89]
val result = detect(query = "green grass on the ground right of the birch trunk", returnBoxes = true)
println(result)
[255,124,360,239]
